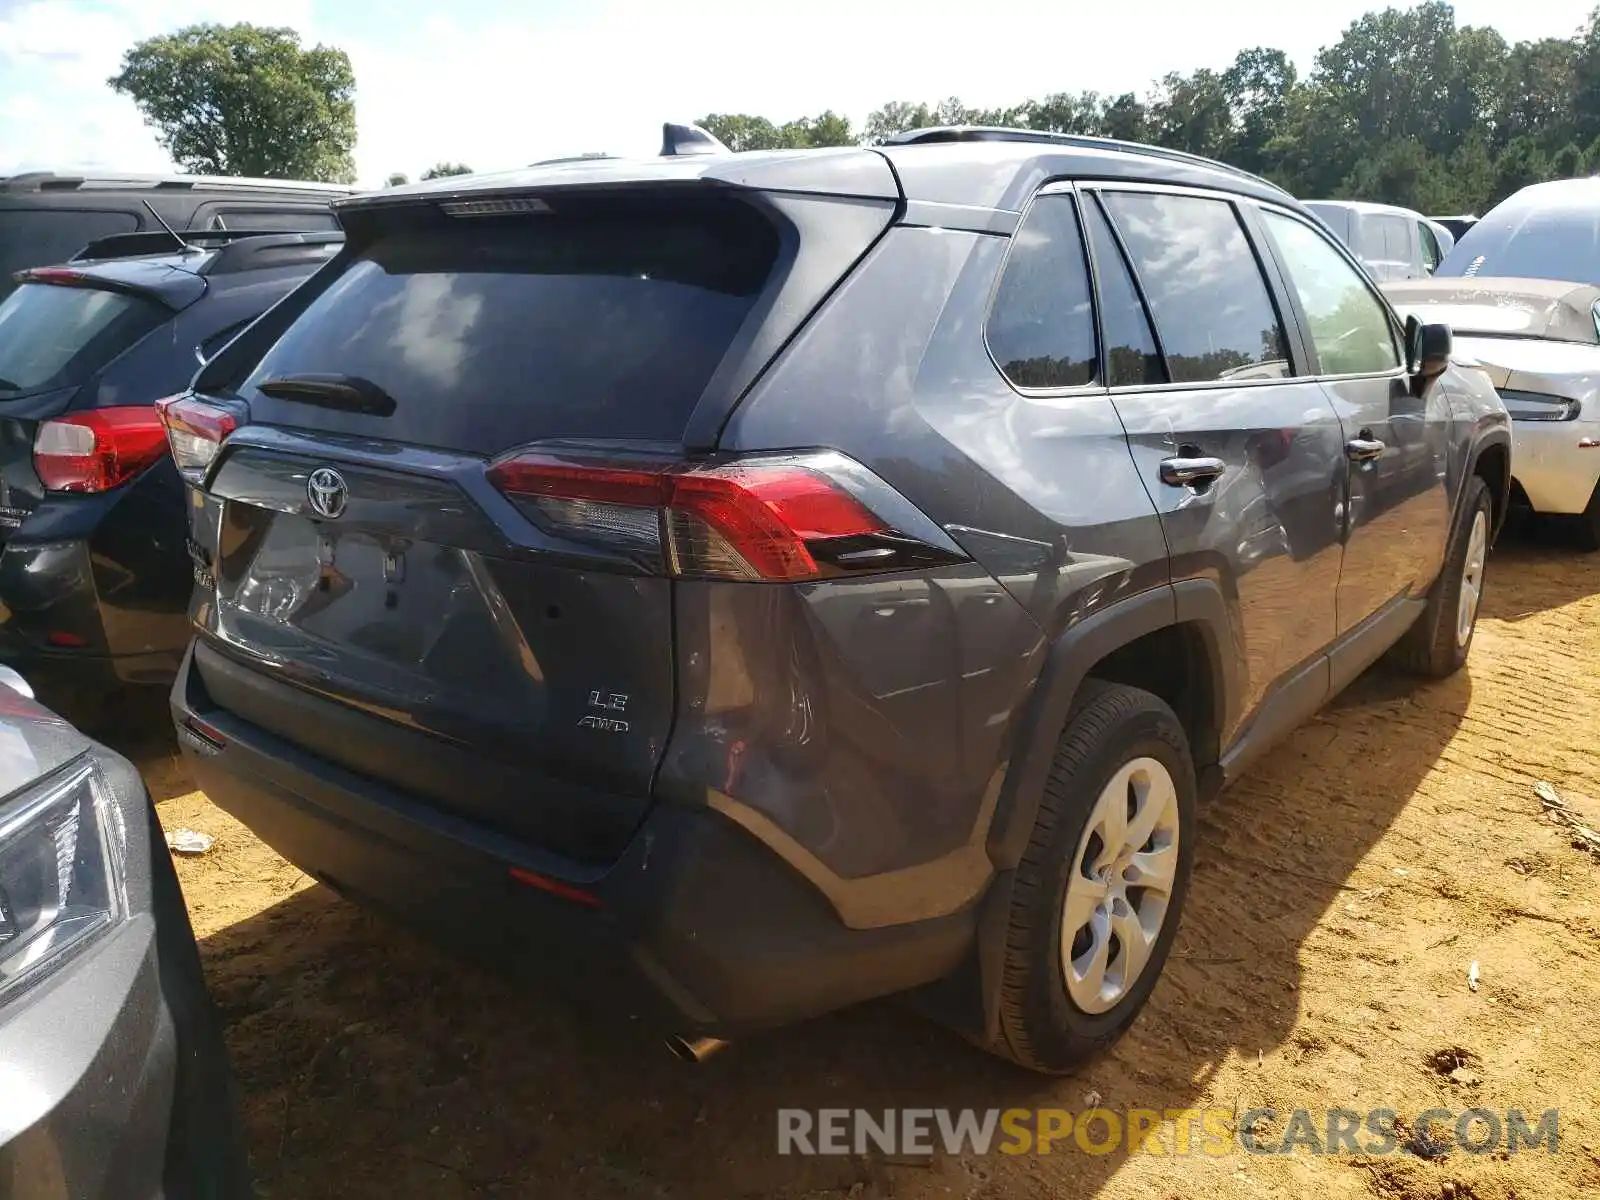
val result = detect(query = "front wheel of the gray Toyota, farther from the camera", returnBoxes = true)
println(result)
[1390,475,1494,678]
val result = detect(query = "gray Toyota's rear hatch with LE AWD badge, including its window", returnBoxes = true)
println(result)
[195,189,893,862]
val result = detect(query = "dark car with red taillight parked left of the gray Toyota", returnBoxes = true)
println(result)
[0,230,342,717]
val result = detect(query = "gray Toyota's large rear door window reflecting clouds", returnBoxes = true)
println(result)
[1106,192,1288,382]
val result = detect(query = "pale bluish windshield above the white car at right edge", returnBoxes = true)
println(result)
[1434,200,1600,283]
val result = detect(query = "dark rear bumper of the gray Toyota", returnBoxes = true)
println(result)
[173,651,976,1037]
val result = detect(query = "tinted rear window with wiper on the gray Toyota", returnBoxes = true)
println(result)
[240,202,778,453]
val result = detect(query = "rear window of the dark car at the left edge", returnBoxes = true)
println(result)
[0,283,170,402]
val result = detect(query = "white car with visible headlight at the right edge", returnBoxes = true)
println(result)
[1382,277,1600,550]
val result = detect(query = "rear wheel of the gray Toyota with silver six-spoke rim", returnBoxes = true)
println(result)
[987,680,1197,1074]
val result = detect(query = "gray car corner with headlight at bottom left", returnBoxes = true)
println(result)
[0,667,250,1200]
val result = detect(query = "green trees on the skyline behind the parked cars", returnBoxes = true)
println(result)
[109,0,1600,213]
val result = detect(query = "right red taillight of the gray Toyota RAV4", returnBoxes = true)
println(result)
[488,453,960,582]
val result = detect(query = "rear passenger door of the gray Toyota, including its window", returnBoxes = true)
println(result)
[1085,186,1344,732]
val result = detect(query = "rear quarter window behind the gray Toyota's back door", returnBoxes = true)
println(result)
[986,195,1096,387]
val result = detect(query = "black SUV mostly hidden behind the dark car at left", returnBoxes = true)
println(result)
[0,171,355,299]
